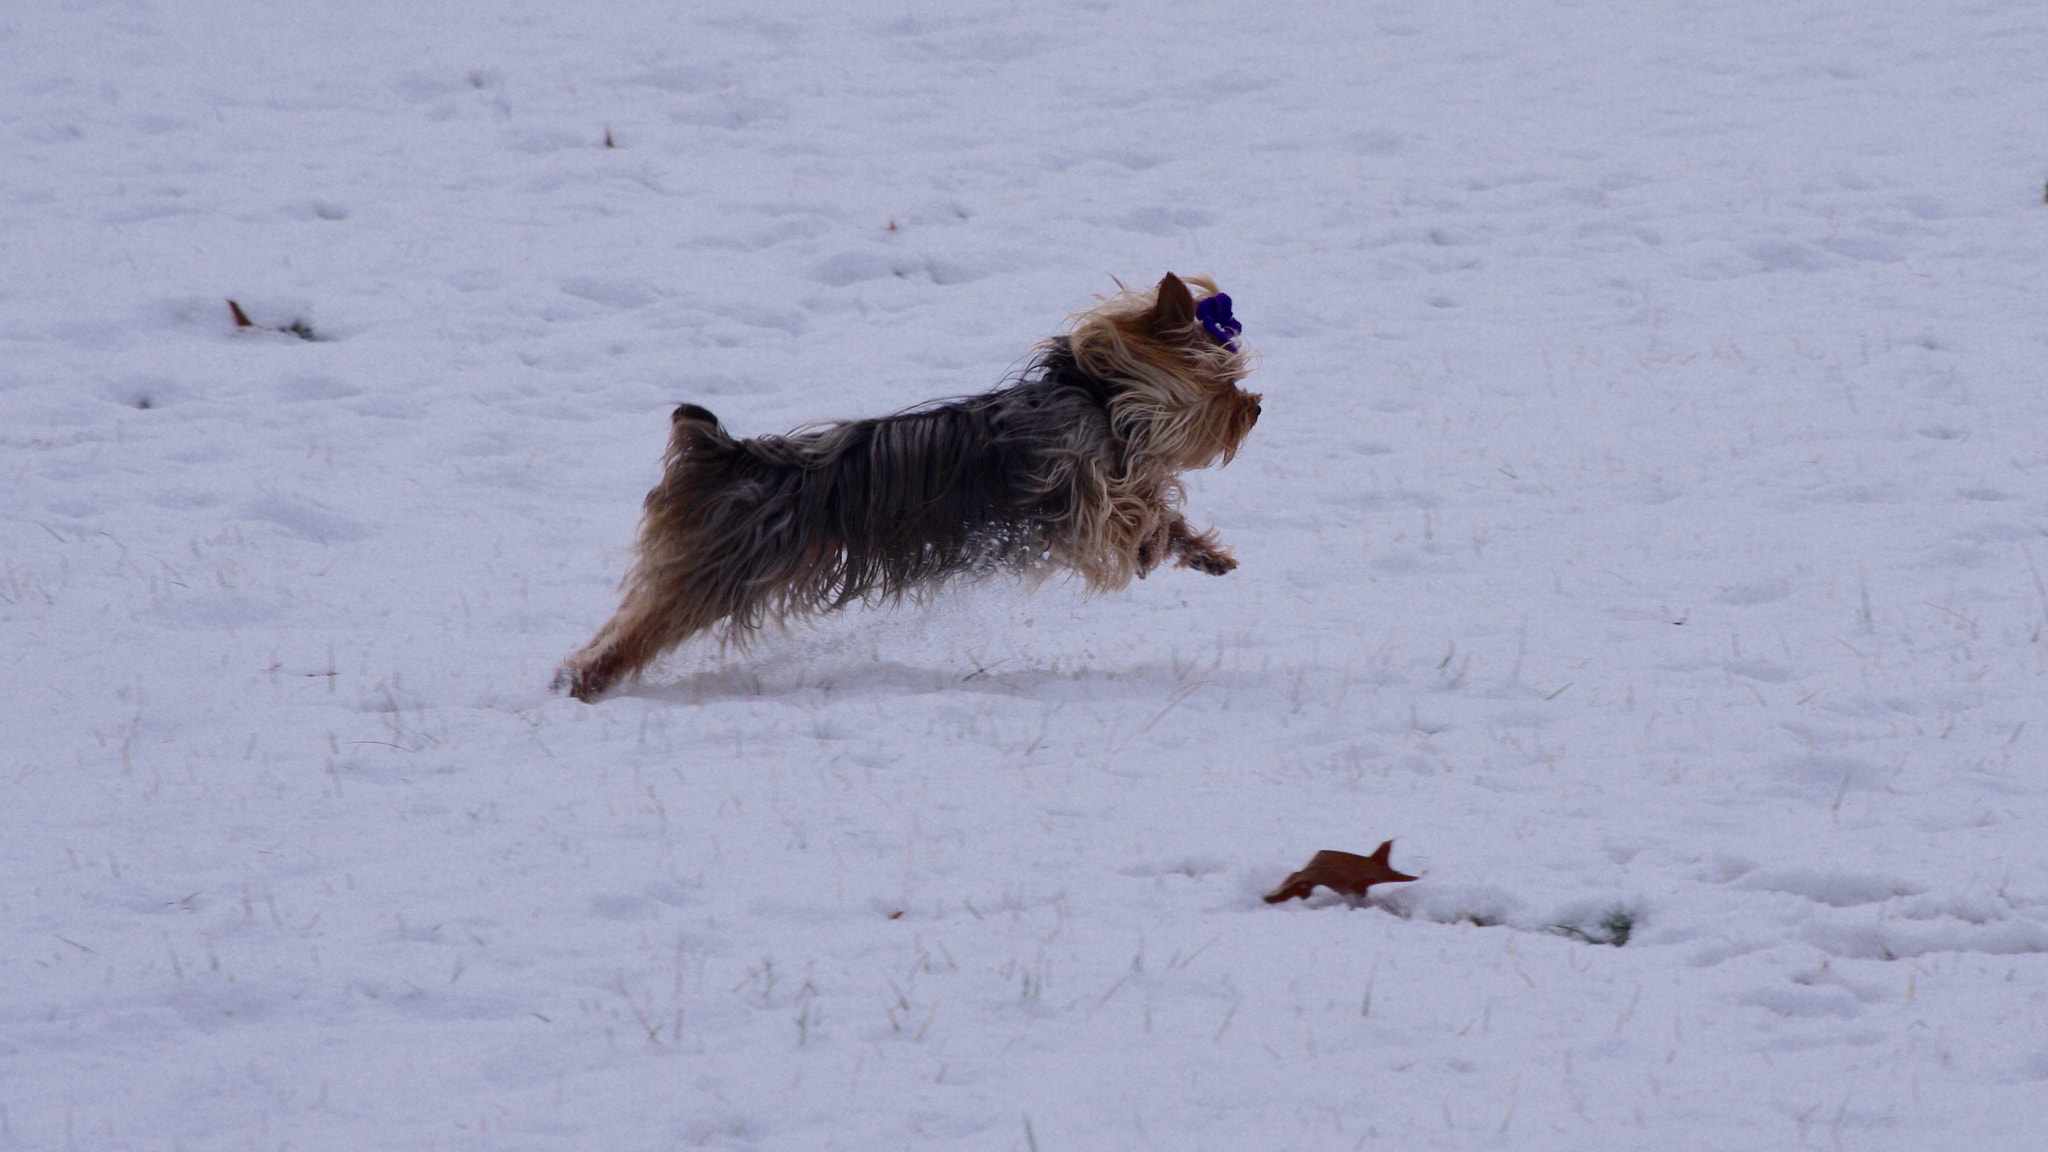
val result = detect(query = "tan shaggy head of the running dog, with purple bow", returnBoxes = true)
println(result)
[1069,273,1262,469]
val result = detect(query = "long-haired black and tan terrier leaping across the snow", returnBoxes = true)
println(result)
[555,273,1260,701]
